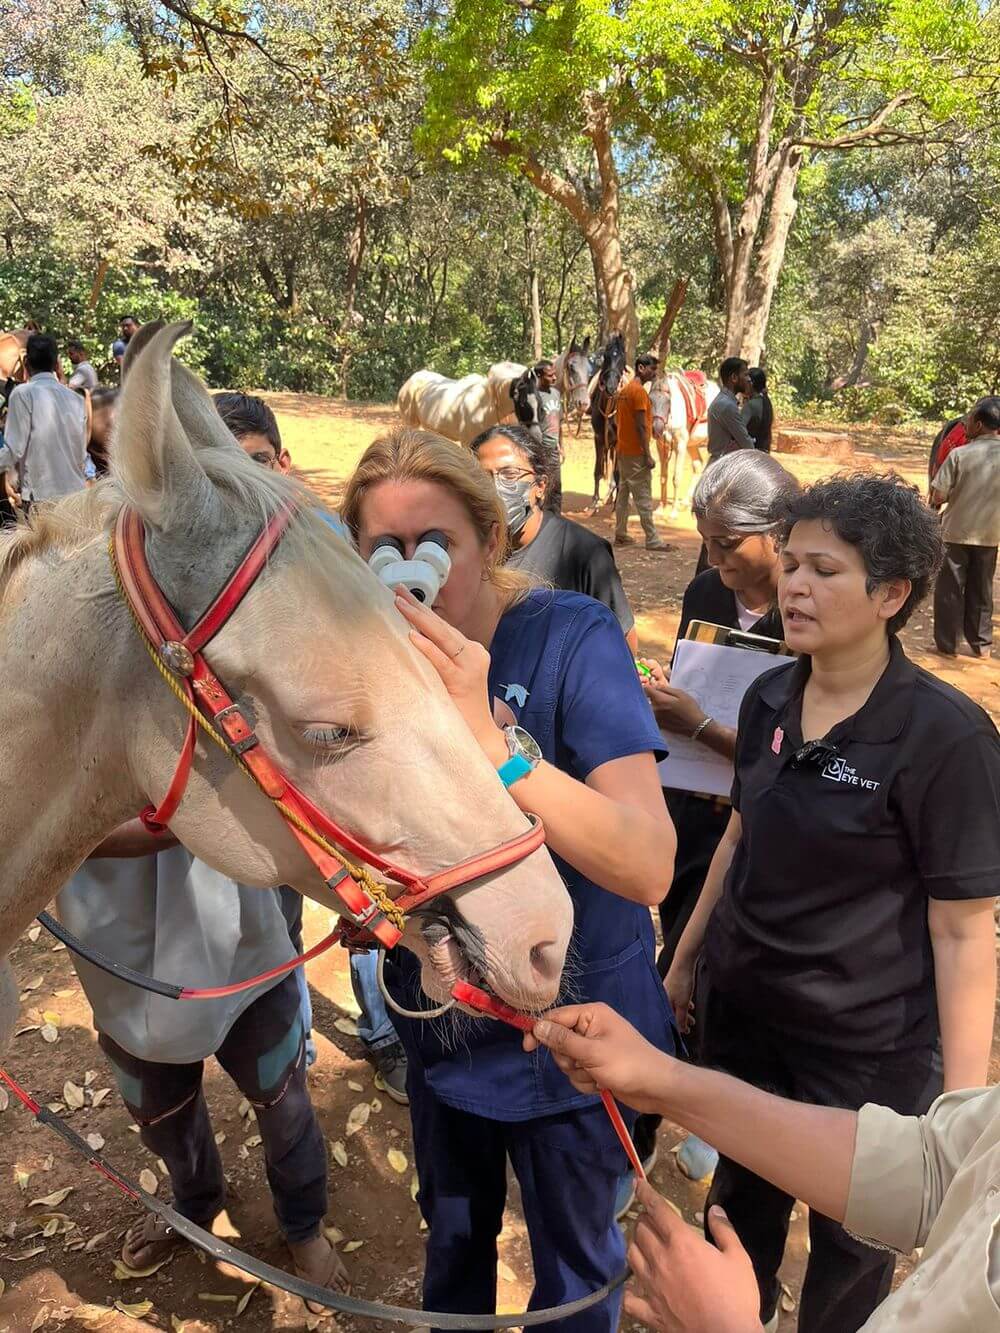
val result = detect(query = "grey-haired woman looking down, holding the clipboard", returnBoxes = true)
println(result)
[629,449,799,1212]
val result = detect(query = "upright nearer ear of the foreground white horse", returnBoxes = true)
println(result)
[111,323,221,528]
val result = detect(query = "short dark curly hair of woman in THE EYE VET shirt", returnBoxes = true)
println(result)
[776,472,944,635]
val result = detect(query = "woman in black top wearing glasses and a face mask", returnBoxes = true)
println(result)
[469,425,639,653]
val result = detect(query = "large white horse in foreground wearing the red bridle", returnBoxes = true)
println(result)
[0,325,572,1053]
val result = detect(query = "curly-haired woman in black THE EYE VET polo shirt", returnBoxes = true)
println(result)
[667,475,1000,1333]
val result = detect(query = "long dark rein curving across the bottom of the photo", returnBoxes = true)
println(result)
[4,1093,631,1333]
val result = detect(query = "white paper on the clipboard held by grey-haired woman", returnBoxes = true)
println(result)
[656,639,787,796]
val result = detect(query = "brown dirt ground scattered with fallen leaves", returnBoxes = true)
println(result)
[0,395,1000,1333]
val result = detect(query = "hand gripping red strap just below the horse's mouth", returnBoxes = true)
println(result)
[524,1004,673,1112]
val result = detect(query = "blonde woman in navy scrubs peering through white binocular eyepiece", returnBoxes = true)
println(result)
[341,429,673,1333]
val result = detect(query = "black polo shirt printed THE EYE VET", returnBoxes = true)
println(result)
[705,637,1000,1054]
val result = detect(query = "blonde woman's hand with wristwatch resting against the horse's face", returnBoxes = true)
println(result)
[396,587,507,765]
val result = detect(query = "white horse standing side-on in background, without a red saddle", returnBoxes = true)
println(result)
[396,361,537,444]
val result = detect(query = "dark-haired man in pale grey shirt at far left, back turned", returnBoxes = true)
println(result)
[0,333,87,503]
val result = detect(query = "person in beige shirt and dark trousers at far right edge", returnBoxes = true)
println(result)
[931,397,1000,657]
